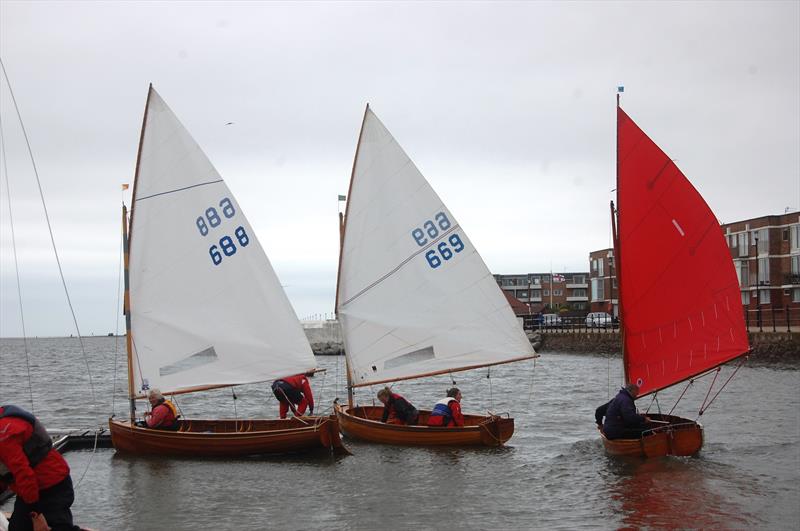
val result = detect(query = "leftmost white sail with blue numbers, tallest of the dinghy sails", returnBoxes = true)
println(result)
[129,88,316,393]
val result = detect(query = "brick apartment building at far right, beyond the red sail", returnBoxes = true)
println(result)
[722,211,800,312]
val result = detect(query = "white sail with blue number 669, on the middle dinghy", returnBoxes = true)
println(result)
[337,108,535,386]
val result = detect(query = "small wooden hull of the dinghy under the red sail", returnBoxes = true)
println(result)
[601,414,703,457]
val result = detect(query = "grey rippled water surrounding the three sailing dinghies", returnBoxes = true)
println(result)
[0,338,800,530]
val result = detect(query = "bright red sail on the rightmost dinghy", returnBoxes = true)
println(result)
[617,107,750,394]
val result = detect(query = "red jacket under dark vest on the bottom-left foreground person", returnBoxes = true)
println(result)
[0,417,69,505]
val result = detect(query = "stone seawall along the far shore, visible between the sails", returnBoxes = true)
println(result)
[303,320,800,364]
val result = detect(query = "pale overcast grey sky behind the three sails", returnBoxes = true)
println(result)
[0,0,800,336]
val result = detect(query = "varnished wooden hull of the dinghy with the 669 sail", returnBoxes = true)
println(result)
[334,404,514,446]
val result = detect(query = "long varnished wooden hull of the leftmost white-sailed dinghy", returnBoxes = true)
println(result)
[108,415,347,457]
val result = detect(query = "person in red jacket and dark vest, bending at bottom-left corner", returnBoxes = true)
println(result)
[0,405,80,531]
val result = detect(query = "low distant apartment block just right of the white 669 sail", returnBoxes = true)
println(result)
[494,272,589,313]
